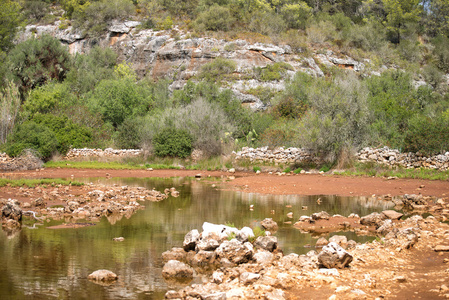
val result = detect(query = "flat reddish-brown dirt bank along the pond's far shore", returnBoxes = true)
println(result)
[0,169,449,197]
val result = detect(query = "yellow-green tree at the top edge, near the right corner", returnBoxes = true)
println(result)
[382,0,422,43]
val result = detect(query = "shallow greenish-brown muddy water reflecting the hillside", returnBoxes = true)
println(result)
[0,178,389,299]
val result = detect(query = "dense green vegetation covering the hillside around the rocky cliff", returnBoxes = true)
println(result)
[0,0,449,161]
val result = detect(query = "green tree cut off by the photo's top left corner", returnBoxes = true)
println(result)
[0,0,22,52]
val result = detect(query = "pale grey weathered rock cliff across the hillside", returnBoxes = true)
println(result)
[19,21,379,110]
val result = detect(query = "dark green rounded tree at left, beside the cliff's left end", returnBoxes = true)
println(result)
[8,34,71,101]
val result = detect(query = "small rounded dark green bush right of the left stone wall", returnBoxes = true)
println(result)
[153,128,192,158]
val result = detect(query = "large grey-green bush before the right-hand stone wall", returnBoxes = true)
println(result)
[300,75,370,162]
